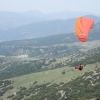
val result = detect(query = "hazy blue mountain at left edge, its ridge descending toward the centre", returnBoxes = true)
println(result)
[0,11,45,30]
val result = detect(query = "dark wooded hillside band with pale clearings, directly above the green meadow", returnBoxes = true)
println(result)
[0,43,100,79]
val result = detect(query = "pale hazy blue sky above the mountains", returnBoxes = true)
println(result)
[0,0,100,14]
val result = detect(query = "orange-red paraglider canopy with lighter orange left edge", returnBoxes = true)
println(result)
[76,17,94,42]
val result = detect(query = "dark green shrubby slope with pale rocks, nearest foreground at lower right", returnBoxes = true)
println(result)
[22,67,100,100]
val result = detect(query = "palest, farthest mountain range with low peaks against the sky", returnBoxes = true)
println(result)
[21,10,100,20]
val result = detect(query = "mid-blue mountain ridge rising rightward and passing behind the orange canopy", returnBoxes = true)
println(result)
[0,15,100,41]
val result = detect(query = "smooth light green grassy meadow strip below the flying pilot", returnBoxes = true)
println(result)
[10,64,96,88]
